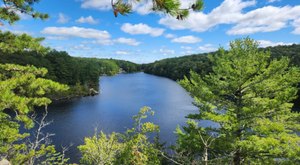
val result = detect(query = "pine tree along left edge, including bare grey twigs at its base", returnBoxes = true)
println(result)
[0,25,68,164]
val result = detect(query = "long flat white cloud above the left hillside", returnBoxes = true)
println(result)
[41,26,110,40]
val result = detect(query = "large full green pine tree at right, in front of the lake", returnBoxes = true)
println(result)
[180,38,300,165]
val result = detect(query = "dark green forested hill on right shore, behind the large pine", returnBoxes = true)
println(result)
[141,44,300,111]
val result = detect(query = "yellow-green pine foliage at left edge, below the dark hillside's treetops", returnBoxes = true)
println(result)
[0,64,68,164]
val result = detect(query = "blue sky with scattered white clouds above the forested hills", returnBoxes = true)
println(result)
[0,0,300,63]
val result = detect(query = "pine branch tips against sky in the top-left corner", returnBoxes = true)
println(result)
[0,0,49,24]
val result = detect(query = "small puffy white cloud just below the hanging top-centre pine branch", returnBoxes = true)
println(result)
[121,23,165,37]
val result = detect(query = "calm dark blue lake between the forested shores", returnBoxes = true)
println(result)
[41,73,197,162]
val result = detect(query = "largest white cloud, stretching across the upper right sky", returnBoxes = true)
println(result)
[159,0,300,35]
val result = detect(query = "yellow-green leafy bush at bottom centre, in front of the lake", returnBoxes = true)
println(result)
[78,107,161,165]
